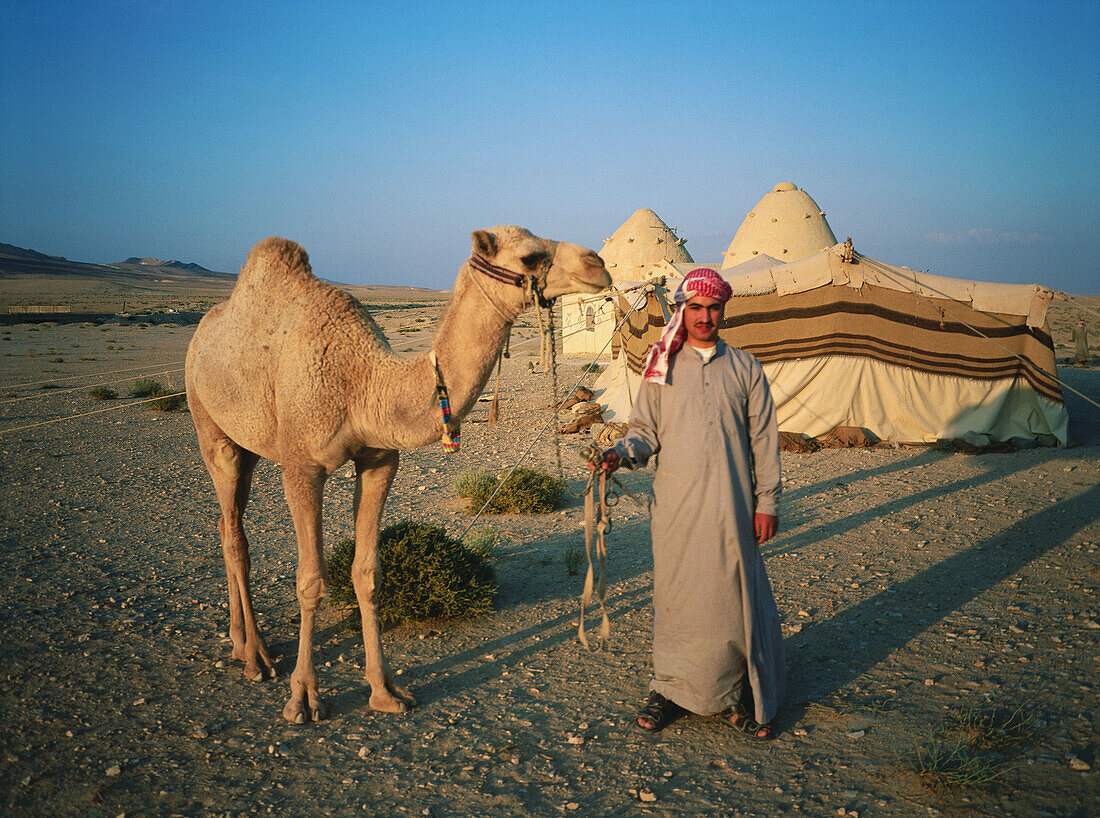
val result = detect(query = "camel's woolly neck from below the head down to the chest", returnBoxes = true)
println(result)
[352,264,524,449]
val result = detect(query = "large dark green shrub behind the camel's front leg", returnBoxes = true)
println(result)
[328,520,497,627]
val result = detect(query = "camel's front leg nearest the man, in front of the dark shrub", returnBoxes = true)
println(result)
[351,452,416,712]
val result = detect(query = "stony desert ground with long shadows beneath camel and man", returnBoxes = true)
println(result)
[0,285,1100,816]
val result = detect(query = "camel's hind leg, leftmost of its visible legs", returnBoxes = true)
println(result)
[188,395,275,682]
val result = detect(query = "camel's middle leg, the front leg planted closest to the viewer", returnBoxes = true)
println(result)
[283,465,328,725]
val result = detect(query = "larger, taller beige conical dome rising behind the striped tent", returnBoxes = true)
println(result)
[722,181,836,269]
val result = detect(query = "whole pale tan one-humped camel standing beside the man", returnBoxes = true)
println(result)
[186,225,611,723]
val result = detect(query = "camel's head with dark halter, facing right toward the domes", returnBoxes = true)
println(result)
[472,224,612,300]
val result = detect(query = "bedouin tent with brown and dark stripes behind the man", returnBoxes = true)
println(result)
[596,241,1068,445]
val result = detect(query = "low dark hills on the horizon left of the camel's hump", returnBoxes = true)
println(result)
[0,243,237,284]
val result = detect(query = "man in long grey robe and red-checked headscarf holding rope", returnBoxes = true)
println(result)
[602,267,787,741]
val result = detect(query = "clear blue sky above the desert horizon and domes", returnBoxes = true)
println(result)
[0,0,1100,294]
